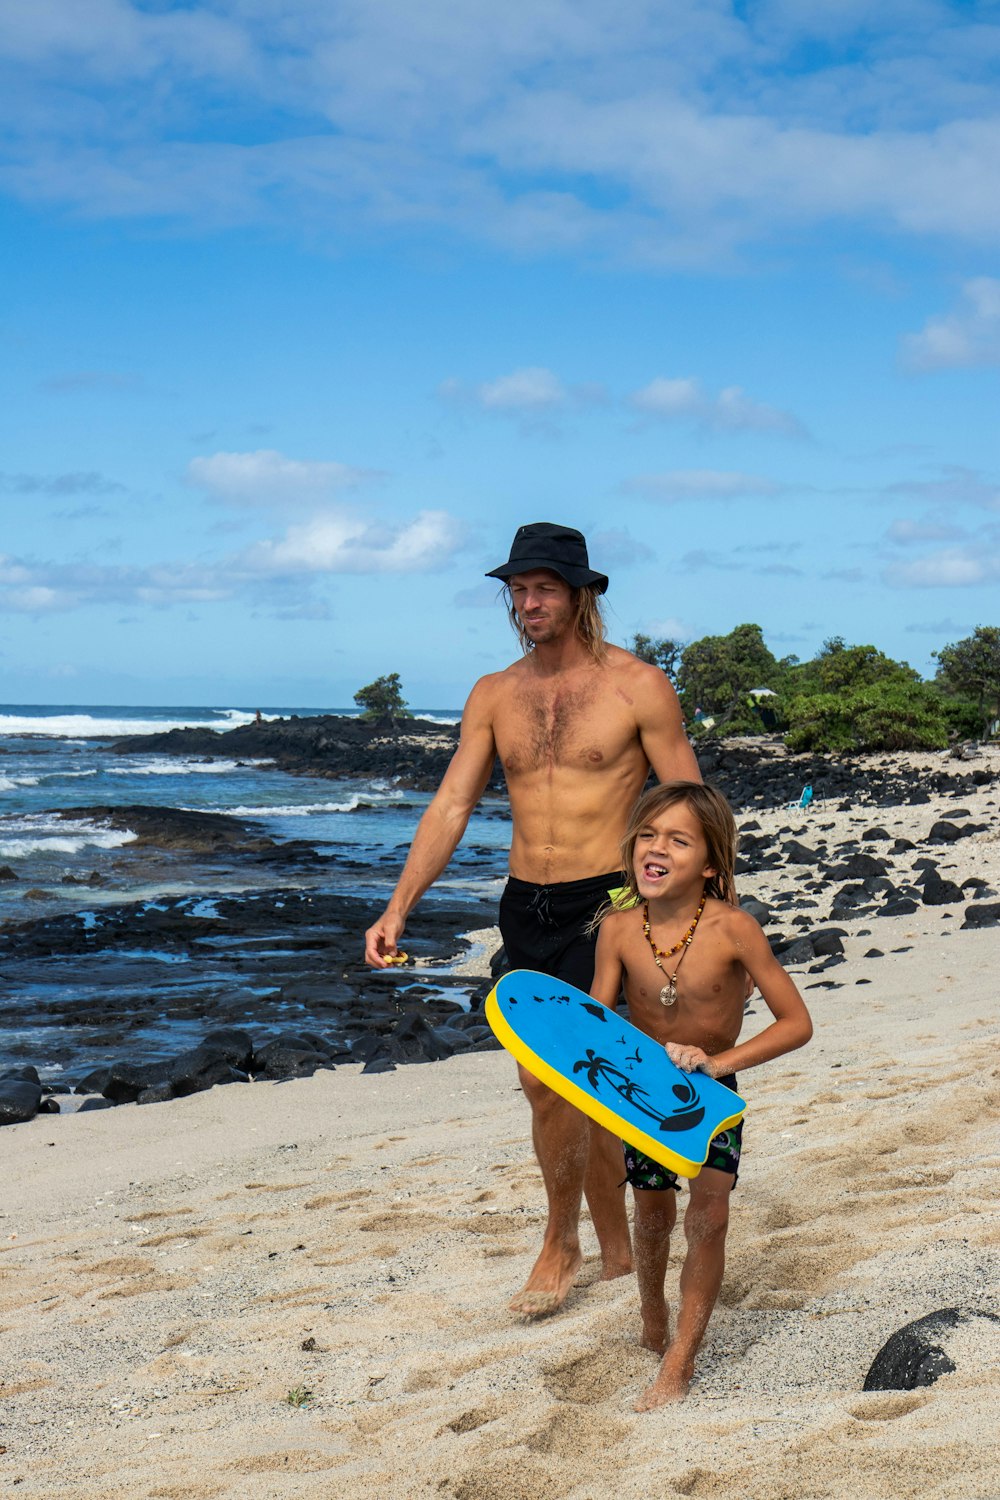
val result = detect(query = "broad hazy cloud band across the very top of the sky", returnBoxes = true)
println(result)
[0,0,1000,264]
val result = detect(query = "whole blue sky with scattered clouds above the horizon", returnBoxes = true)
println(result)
[0,0,1000,707]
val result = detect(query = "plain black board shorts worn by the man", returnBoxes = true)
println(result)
[499,870,624,992]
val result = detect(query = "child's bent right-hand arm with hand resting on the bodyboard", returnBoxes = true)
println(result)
[667,912,813,1079]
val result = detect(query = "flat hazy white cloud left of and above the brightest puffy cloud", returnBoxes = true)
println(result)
[186,449,381,506]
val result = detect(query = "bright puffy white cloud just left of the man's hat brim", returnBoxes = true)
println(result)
[240,510,465,578]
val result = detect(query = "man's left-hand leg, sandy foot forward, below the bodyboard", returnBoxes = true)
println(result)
[510,1068,591,1317]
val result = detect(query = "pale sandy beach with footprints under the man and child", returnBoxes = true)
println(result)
[0,753,1000,1500]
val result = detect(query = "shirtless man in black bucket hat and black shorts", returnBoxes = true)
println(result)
[364,522,700,1317]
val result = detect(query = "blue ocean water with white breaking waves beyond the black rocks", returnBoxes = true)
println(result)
[0,704,508,921]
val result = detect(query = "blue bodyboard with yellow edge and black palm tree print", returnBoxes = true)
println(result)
[486,969,747,1178]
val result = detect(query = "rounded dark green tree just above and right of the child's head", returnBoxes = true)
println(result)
[678,626,787,734]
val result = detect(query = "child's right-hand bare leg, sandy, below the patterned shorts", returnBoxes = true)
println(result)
[636,1167,733,1412]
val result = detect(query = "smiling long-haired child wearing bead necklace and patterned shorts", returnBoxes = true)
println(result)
[591,782,813,1412]
